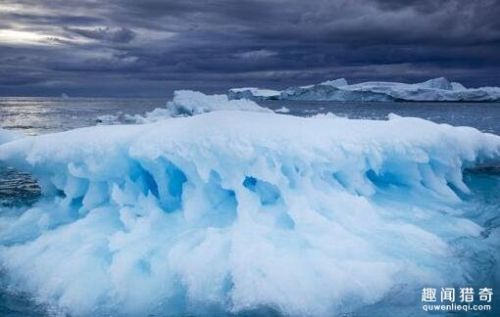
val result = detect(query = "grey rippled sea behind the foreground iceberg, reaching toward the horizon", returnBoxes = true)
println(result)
[0,97,500,135]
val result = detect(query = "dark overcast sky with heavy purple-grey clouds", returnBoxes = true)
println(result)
[0,0,500,96]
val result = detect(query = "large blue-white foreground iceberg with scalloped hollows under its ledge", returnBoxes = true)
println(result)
[0,93,500,316]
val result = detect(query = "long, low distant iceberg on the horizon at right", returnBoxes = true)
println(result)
[228,77,500,102]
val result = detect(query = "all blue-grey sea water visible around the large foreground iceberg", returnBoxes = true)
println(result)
[0,98,500,316]
